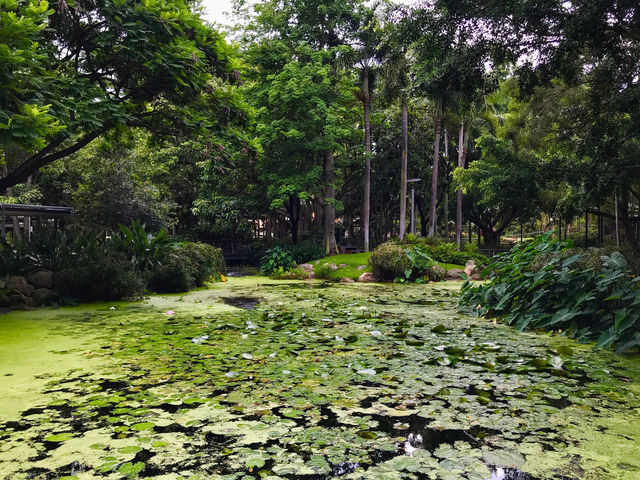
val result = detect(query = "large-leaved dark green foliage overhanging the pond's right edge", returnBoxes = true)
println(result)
[460,233,640,350]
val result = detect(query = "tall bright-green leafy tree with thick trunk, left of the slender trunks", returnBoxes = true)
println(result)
[245,0,363,253]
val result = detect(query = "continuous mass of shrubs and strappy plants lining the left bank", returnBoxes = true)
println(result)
[0,222,225,301]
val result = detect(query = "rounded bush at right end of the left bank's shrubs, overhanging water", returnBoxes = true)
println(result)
[148,242,225,293]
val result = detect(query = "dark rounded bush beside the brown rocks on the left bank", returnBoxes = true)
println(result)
[54,251,145,302]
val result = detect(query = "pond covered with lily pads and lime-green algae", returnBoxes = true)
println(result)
[0,277,640,480]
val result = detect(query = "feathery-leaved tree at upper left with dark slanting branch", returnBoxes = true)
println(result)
[0,0,246,190]
